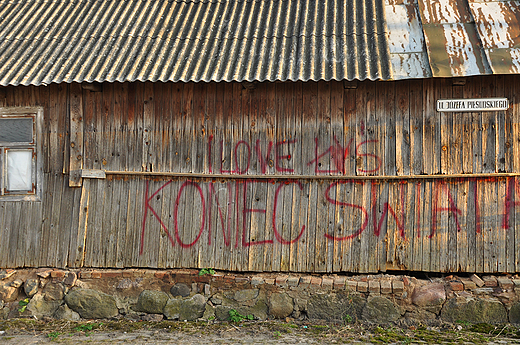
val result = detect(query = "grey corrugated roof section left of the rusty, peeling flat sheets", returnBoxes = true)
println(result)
[0,0,392,85]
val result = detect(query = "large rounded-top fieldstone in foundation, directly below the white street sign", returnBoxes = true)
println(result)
[441,297,507,323]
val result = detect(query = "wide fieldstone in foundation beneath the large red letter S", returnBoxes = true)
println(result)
[307,293,366,321]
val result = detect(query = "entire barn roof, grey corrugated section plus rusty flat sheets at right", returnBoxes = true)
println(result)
[0,0,520,85]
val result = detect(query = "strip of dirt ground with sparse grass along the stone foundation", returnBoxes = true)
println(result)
[0,319,520,345]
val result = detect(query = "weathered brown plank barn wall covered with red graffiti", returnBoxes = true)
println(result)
[0,76,520,272]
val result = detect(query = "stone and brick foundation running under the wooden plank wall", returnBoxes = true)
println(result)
[0,268,520,325]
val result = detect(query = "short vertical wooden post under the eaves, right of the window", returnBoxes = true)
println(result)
[69,83,83,187]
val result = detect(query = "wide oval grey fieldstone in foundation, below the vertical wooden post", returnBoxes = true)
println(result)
[65,289,119,319]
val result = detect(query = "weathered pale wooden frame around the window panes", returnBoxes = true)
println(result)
[0,107,43,202]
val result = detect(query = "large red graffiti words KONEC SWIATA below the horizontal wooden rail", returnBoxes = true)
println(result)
[139,172,520,254]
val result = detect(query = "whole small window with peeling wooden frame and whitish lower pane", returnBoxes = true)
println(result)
[0,108,43,201]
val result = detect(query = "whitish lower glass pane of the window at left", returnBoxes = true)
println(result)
[6,150,33,192]
